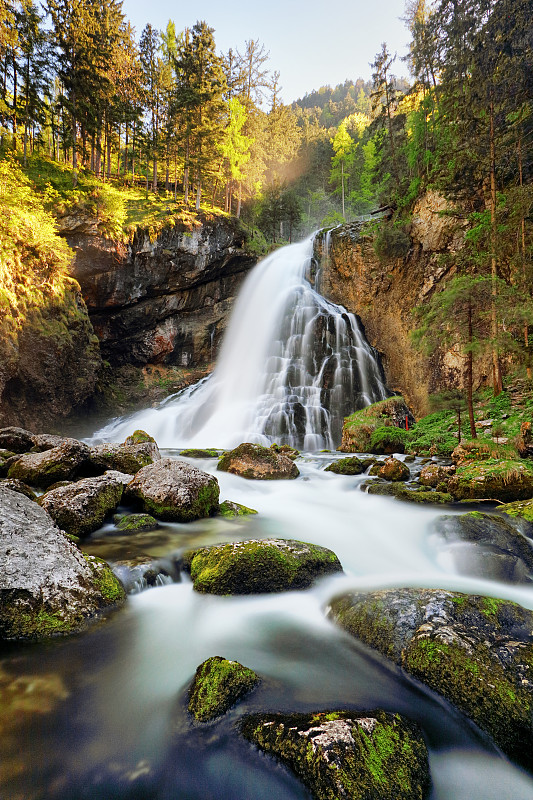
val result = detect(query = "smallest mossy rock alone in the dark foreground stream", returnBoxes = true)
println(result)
[188,656,260,722]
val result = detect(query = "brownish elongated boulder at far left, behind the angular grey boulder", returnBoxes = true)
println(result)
[8,439,90,489]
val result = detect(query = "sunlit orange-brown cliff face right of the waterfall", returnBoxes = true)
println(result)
[316,192,472,416]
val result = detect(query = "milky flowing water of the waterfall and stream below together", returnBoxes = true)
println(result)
[0,239,533,800]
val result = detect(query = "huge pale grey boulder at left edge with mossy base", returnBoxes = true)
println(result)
[0,487,125,639]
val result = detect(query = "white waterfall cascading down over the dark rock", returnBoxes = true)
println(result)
[96,238,387,450]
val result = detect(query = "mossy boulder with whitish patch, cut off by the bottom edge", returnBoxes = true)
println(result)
[240,711,430,800]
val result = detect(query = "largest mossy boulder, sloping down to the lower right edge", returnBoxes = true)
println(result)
[328,589,533,769]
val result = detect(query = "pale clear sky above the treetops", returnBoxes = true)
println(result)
[122,0,409,103]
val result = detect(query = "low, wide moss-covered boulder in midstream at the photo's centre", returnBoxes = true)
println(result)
[183,539,342,595]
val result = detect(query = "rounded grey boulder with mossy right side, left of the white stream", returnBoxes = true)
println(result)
[127,458,220,522]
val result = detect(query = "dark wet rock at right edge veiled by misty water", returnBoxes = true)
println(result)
[433,511,533,583]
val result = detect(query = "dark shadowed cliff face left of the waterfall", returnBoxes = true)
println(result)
[65,217,254,367]
